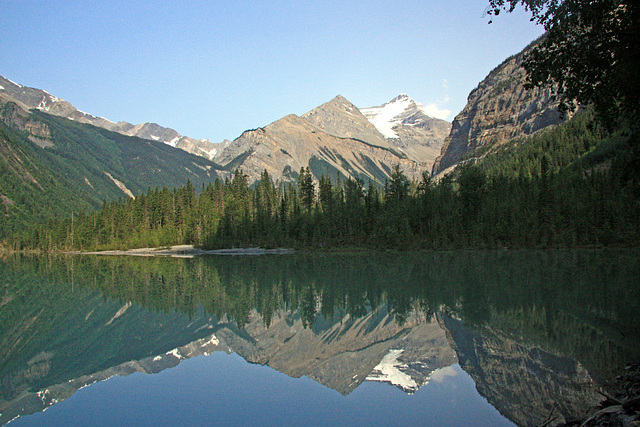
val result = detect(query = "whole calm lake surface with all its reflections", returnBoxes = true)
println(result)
[0,250,640,426]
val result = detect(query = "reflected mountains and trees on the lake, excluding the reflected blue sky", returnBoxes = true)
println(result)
[0,251,640,425]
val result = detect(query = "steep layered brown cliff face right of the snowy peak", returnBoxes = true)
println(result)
[432,40,562,175]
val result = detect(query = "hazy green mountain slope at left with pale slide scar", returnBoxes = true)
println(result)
[0,102,224,239]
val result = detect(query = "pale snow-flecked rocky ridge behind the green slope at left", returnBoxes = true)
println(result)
[0,76,223,160]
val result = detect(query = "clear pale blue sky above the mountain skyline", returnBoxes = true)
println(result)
[0,0,542,142]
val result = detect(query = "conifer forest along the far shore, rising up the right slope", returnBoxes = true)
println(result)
[12,108,640,250]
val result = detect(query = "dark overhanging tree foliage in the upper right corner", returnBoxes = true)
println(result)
[488,0,640,130]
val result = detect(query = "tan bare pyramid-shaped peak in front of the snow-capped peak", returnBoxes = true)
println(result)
[214,99,421,182]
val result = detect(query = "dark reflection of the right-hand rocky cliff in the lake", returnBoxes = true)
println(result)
[440,316,602,426]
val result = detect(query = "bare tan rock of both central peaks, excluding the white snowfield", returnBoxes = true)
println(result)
[214,95,446,182]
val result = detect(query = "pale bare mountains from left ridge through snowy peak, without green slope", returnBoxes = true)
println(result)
[0,73,451,183]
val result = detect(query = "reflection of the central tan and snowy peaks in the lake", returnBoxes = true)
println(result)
[216,307,456,395]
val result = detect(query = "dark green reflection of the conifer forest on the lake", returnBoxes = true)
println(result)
[8,251,640,380]
